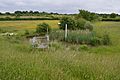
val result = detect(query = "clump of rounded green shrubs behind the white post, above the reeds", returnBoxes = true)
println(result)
[60,17,93,31]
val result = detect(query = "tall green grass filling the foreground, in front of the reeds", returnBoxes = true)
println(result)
[0,37,120,80]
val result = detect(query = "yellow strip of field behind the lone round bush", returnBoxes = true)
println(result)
[0,20,59,29]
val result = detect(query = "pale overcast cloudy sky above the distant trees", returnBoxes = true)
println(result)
[0,0,120,14]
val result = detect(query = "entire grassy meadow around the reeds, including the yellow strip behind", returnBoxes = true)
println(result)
[0,20,120,80]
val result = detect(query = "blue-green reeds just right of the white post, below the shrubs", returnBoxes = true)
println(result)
[66,31,94,44]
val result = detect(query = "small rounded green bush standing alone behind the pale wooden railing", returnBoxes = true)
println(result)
[36,23,51,35]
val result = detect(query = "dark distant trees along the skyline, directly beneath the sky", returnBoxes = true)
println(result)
[0,10,120,17]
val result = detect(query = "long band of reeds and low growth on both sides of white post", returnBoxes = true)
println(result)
[50,30,111,46]
